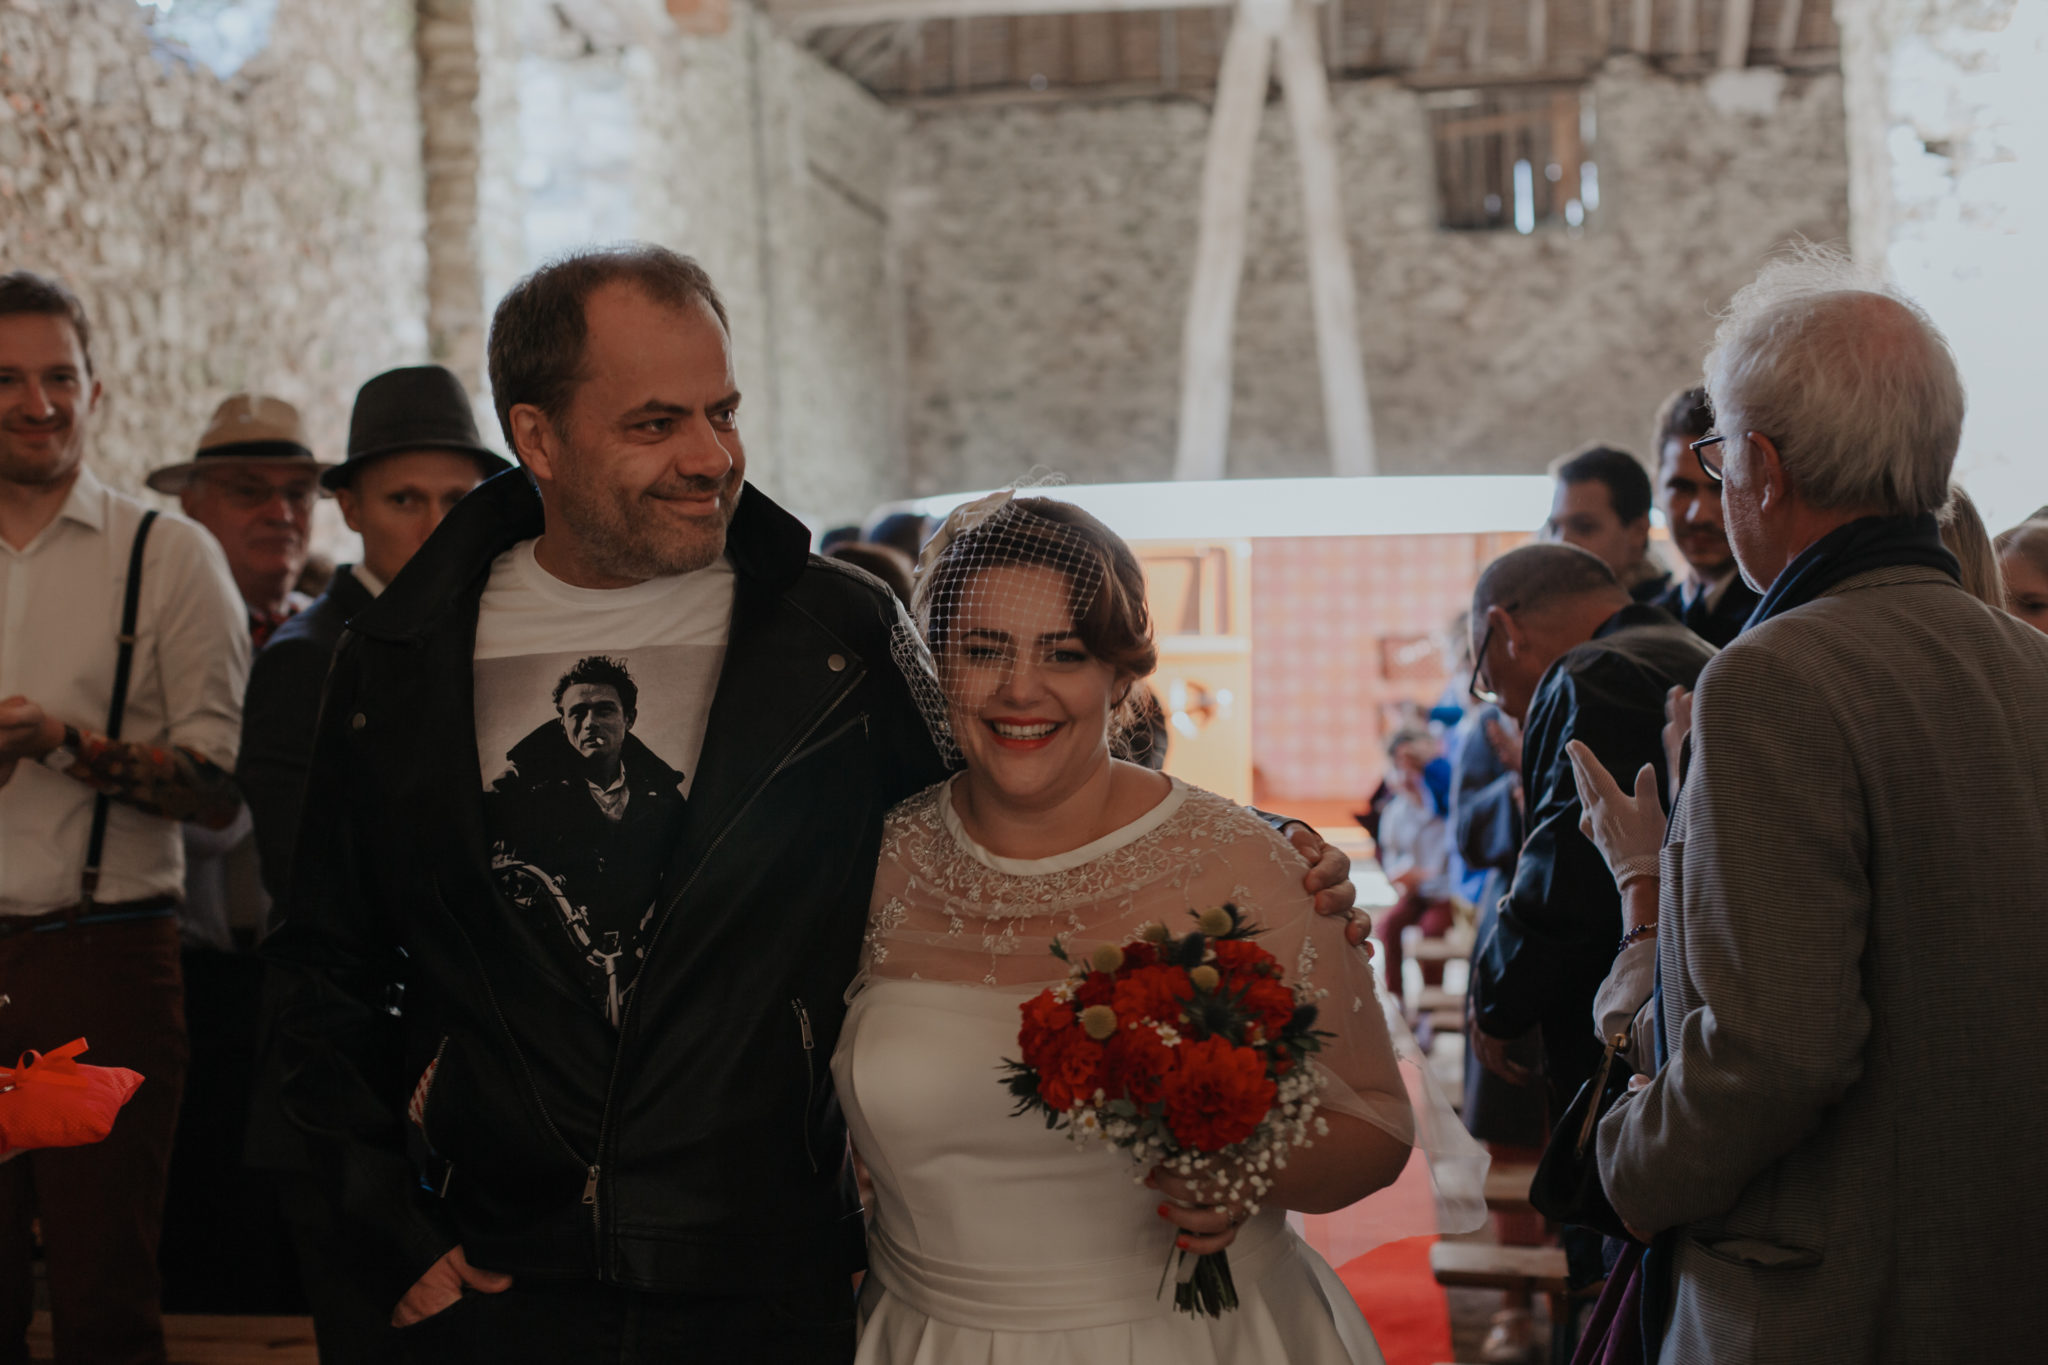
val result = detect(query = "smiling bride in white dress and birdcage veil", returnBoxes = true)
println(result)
[831,495,1458,1365]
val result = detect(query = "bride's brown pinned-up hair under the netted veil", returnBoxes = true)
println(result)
[924,497,1159,712]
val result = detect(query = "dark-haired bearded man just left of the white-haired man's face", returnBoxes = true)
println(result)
[1651,389,1757,649]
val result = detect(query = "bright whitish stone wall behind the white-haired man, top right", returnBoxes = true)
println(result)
[1835,0,2048,532]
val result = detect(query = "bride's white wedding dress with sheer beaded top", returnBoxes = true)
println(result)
[831,782,1434,1365]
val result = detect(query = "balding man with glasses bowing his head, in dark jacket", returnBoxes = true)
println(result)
[1470,544,1714,1113]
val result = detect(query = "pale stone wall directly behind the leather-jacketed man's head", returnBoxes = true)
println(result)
[477,0,905,524]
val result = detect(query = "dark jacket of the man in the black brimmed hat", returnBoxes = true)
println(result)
[236,565,375,919]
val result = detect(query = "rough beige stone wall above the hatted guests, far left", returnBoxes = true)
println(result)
[0,0,426,499]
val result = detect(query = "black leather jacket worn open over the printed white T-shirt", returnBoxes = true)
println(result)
[266,471,946,1302]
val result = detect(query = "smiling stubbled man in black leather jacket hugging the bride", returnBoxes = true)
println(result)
[268,246,1358,1365]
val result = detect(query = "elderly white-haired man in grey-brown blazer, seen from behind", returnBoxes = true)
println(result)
[1591,250,2048,1365]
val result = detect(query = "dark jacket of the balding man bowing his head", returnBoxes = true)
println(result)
[1470,604,1714,1105]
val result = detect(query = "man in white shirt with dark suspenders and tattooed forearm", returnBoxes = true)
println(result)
[0,272,250,1365]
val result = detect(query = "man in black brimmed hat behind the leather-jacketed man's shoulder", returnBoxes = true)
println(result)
[236,364,510,1365]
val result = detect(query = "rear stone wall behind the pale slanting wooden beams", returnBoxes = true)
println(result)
[891,59,1847,493]
